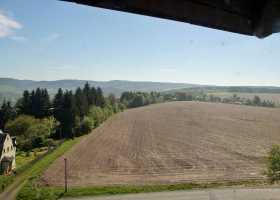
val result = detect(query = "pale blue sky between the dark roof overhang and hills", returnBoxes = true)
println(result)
[0,0,280,86]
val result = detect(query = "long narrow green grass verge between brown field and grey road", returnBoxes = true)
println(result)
[17,179,268,200]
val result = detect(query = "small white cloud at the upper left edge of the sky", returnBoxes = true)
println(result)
[0,10,22,38]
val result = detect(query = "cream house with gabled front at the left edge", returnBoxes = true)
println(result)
[0,130,16,175]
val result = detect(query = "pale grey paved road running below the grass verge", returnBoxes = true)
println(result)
[63,188,280,200]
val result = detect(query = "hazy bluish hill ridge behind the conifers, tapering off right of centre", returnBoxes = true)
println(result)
[0,78,196,102]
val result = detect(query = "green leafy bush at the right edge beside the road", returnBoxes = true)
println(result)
[266,145,280,183]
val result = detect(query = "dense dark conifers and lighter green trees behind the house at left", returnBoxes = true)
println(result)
[0,83,124,150]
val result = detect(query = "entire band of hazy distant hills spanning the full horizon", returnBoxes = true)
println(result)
[0,78,280,102]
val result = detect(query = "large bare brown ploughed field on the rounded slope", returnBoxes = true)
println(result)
[42,102,280,186]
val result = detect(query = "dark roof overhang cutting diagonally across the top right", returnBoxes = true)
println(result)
[63,0,280,38]
